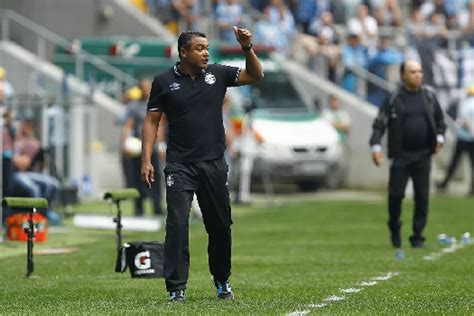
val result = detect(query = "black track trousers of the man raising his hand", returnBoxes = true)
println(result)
[164,158,232,291]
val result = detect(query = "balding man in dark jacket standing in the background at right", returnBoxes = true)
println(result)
[370,61,446,248]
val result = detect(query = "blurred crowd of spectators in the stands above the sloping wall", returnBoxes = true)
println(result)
[132,0,474,105]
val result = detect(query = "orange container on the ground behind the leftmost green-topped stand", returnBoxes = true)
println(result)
[6,213,48,242]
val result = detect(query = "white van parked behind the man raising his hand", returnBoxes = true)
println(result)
[227,62,343,190]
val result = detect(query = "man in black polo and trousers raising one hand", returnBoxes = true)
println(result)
[141,27,263,301]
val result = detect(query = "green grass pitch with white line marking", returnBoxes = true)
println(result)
[0,197,474,315]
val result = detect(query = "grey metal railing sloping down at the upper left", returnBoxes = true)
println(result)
[0,10,138,86]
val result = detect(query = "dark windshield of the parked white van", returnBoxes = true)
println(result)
[246,72,309,113]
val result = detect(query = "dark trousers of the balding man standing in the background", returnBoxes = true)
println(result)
[388,153,431,239]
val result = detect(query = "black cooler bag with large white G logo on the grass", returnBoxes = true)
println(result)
[115,241,164,278]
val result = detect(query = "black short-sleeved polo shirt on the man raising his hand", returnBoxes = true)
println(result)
[147,63,240,162]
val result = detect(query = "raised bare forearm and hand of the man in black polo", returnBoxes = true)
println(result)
[234,26,263,85]
